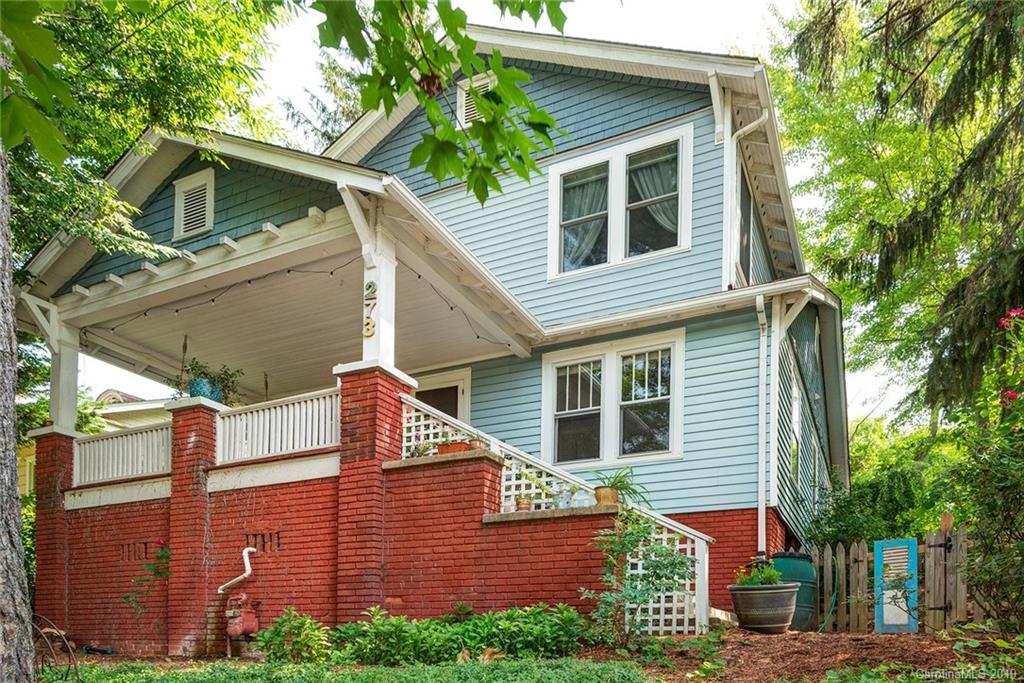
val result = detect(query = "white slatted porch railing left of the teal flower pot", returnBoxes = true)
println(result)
[72,422,171,486]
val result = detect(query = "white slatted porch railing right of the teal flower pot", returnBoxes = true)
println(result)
[217,387,340,464]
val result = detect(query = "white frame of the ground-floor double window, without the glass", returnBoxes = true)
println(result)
[541,328,686,472]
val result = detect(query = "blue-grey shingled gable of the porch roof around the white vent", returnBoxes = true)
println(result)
[61,154,341,293]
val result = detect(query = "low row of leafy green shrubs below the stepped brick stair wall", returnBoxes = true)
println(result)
[335,604,587,665]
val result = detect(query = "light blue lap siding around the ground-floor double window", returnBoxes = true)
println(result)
[415,311,759,513]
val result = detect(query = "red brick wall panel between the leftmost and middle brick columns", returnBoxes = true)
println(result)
[67,499,174,655]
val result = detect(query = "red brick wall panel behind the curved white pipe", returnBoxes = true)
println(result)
[210,477,338,639]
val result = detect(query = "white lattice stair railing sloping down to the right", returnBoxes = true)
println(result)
[401,394,712,635]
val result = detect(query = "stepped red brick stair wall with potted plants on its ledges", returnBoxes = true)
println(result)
[384,459,611,616]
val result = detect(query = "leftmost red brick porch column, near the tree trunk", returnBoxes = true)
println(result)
[29,427,78,629]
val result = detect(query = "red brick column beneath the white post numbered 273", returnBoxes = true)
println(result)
[334,362,416,623]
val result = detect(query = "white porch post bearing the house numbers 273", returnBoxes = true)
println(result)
[362,226,398,368]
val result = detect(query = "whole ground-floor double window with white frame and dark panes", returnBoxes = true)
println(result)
[541,330,685,466]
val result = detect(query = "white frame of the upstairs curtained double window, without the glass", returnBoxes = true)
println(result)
[548,122,693,282]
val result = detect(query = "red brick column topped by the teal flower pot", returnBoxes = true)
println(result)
[166,398,225,655]
